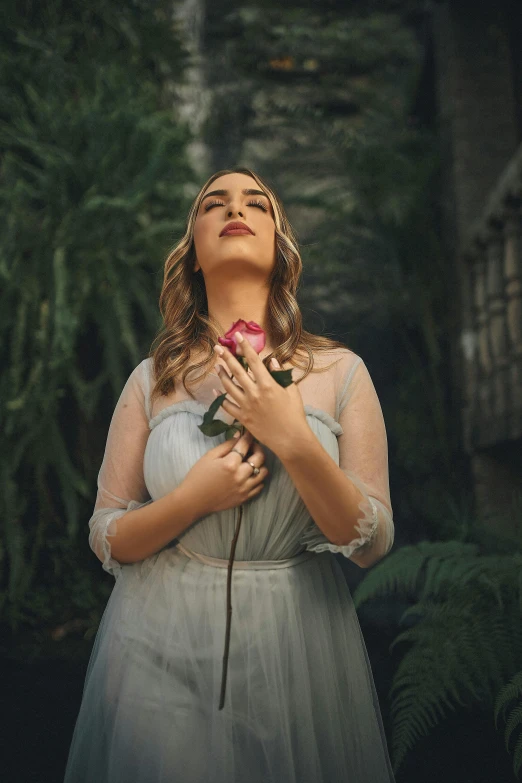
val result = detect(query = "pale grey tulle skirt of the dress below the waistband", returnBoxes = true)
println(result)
[65,544,394,783]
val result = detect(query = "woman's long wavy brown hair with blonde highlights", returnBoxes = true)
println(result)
[149,168,347,399]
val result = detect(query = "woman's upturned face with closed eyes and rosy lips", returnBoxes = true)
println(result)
[194,174,276,278]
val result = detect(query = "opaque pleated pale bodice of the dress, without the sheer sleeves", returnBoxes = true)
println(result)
[144,400,342,560]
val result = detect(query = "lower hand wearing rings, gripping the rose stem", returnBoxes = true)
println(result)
[183,430,268,518]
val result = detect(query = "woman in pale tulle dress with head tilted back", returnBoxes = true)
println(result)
[65,169,394,783]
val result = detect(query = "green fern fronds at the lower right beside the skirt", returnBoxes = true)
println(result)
[354,541,522,772]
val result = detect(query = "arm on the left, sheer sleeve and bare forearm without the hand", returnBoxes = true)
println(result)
[89,362,196,578]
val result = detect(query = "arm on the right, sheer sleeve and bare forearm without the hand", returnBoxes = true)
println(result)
[280,358,394,568]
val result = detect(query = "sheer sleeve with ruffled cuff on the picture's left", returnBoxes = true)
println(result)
[89,359,152,579]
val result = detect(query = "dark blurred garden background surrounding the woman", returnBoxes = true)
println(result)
[0,0,522,783]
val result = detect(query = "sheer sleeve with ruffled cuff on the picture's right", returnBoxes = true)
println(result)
[302,357,395,567]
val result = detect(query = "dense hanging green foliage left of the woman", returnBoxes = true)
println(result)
[0,0,192,630]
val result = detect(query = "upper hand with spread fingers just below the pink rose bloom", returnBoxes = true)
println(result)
[214,332,311,456]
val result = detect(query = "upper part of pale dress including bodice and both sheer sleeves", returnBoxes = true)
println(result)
[89,349,394,576]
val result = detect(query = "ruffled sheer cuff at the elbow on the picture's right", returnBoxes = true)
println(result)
[300,470,394,560]
